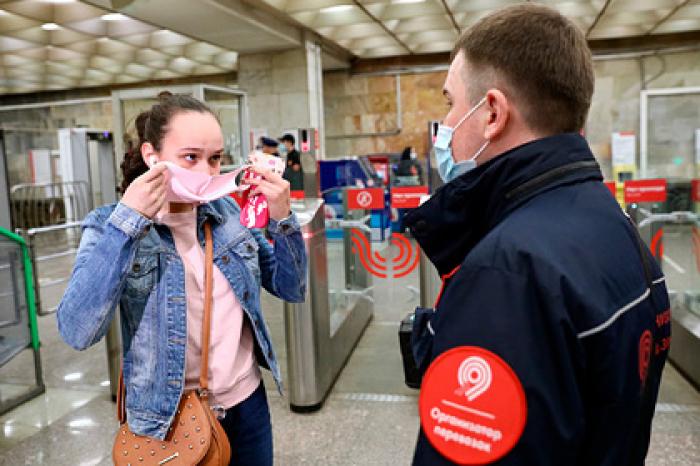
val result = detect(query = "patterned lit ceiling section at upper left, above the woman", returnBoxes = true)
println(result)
[0,0,238,93]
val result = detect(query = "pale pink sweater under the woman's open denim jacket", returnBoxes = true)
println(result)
[157,209,261,408]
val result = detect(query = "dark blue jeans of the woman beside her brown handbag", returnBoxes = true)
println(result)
[221,382,272,466]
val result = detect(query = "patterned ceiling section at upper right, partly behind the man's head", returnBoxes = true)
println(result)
[262,0,700,58]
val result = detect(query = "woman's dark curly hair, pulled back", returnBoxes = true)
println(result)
[120,91,216,194]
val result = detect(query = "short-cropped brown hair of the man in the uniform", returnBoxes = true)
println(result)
[452,3,595,136]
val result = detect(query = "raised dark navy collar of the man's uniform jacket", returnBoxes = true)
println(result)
[404,133,603,275]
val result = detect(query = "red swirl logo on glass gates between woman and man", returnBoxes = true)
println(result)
[350,228,420,278]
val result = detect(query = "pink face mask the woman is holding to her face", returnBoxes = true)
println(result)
[150,157,247,204]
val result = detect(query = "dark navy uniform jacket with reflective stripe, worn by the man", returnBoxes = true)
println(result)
[406,134,670,466]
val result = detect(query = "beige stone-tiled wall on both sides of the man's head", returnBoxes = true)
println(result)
[324,47,700,177]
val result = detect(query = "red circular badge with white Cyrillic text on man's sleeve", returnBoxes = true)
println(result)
[418,346,527,464]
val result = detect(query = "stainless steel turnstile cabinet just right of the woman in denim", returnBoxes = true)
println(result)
[284,198,374,412]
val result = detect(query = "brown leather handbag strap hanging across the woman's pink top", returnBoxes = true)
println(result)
[117,222,214,424]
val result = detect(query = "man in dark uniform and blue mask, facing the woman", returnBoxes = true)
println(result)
[406,3,670,466]
